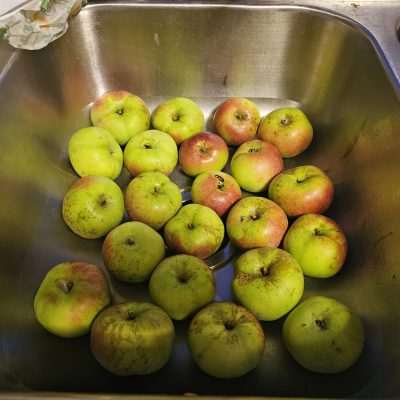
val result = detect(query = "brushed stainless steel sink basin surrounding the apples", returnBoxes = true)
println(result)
[0,1,400,398]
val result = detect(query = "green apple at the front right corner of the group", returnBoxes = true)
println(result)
[282,296,364,374]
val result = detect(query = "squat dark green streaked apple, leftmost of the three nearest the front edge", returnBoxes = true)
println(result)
[90,302,175,376]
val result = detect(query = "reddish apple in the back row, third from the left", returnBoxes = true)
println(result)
[213,97,260,146]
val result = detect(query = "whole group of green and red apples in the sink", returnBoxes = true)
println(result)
[34,91,364,378]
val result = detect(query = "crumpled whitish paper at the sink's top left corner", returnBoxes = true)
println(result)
[0,0,87,50]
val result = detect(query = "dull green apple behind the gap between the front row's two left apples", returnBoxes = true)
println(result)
[149,254,215,320]
